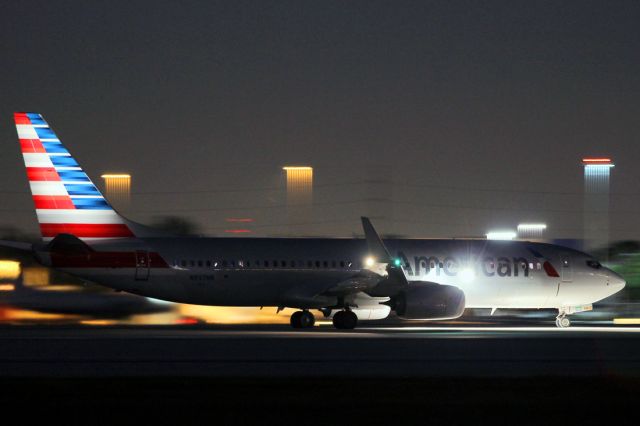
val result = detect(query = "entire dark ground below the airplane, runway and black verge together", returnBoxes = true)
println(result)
[0,326,640,425]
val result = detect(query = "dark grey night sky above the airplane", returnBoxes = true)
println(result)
[0,0,640,239]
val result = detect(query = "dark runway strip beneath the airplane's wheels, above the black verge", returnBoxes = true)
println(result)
[0,325,640,378]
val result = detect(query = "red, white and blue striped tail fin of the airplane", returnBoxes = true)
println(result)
[14,112,135,242]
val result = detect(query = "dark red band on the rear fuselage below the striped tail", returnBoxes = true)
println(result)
[51,251,169,268]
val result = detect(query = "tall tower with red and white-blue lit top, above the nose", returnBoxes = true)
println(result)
[582,157,614,261]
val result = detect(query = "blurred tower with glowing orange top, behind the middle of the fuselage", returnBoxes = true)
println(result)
[282,166,313,233]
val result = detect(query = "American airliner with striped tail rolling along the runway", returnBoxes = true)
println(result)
[5,112,625,329]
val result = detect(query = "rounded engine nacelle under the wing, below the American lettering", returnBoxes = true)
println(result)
[392,283,465,320]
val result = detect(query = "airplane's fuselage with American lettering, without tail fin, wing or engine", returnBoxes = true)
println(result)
[45,238,624,314]
